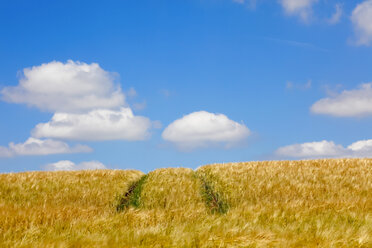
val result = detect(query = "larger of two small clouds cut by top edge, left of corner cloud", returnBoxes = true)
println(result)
[279,0,318,21]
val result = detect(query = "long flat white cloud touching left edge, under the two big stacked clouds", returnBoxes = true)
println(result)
[0,138,92,157]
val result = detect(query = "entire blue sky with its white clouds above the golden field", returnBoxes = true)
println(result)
[0,0,372,172]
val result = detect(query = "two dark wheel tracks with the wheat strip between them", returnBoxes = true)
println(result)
[116,168,229,214]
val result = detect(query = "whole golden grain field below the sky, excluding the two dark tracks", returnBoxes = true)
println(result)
[0,159,372,247]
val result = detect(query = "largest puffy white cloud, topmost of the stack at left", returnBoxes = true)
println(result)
[1,60,124,112]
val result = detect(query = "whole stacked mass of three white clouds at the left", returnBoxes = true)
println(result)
[0,60,156,154]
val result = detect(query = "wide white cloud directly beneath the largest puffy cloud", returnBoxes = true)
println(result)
[32,108,152,141]
